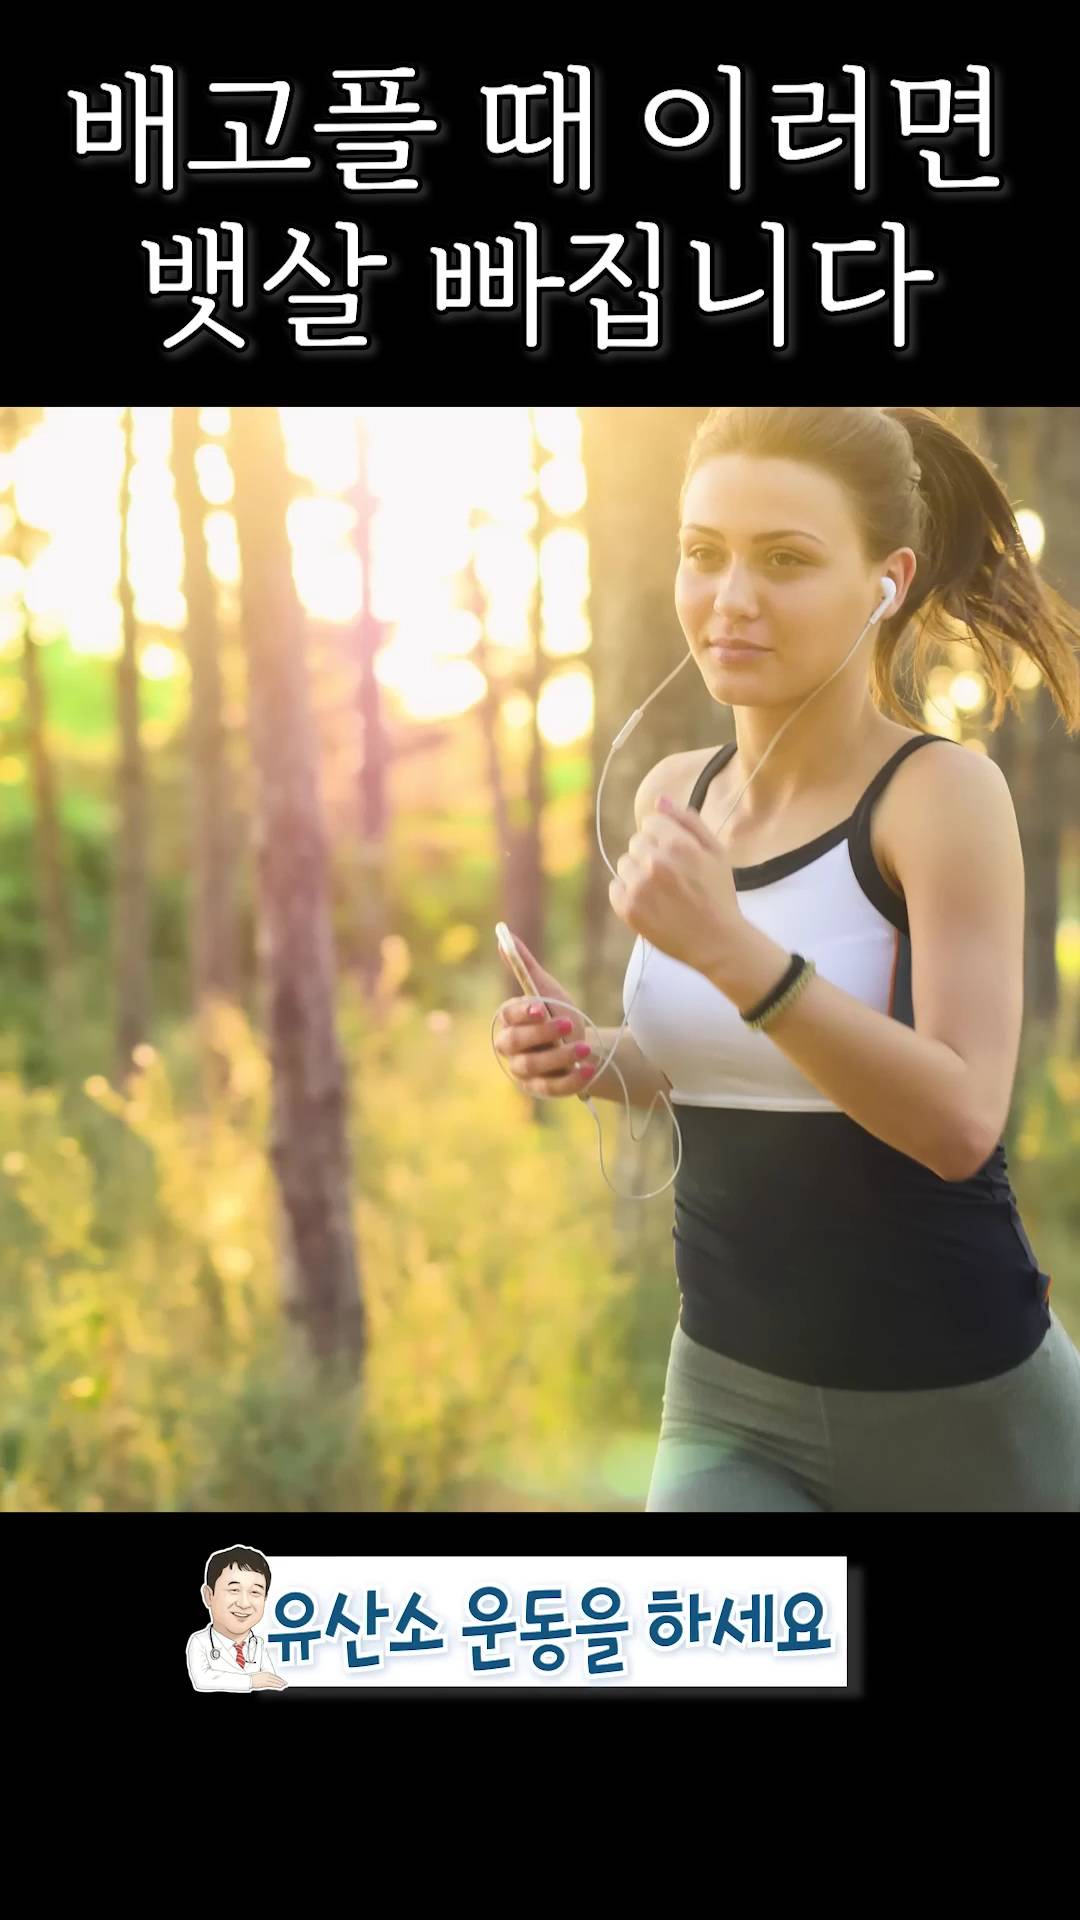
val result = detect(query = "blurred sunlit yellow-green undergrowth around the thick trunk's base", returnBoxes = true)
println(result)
[0,993,644,1511]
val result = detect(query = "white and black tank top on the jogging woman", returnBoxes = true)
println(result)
[623,733,1051,1390]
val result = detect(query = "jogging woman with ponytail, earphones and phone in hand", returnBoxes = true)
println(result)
[496,407,1080,1513]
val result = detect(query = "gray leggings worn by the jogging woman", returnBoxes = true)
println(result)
[646,1308,1080,1513]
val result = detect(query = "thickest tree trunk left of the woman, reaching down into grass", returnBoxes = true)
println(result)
[231,407,365,1380]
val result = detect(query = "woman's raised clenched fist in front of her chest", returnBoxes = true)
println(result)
[607,793,746,973]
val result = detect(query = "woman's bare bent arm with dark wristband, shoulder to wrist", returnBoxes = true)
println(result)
[707,753,1024,1181]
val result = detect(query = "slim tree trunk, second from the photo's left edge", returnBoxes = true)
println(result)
[115,407,150,1087]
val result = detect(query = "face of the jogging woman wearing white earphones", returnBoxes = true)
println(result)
[675,453,899,707]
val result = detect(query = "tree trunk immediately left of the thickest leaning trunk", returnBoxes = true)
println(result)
[173,407,240,1081]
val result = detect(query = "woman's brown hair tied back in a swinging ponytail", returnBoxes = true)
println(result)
[678,407,1080,733]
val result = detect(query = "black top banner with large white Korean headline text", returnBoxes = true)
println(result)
[2,41,1074,403]
